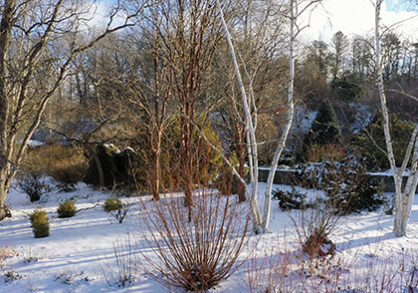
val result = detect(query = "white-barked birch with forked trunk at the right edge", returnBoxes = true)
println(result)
[374,0,418,237]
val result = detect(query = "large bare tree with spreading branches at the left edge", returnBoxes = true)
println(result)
[0,0,146,219]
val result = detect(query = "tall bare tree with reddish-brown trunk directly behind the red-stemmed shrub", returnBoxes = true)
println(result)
[145,0,225,219]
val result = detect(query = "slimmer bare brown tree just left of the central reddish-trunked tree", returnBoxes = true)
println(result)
[126,26,173,200]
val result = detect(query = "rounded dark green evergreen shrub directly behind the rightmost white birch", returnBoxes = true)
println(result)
[353,113,414,170]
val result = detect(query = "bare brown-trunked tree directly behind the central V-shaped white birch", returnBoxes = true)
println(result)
[211,0,287,202]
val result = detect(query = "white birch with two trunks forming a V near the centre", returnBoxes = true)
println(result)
[216,0,321,233]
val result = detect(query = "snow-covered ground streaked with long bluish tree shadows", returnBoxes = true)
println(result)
[0,184,418,293]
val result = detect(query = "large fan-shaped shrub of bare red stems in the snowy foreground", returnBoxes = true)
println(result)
[143,189,249,292]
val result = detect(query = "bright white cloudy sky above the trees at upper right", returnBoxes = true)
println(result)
[301,0,418,42]
